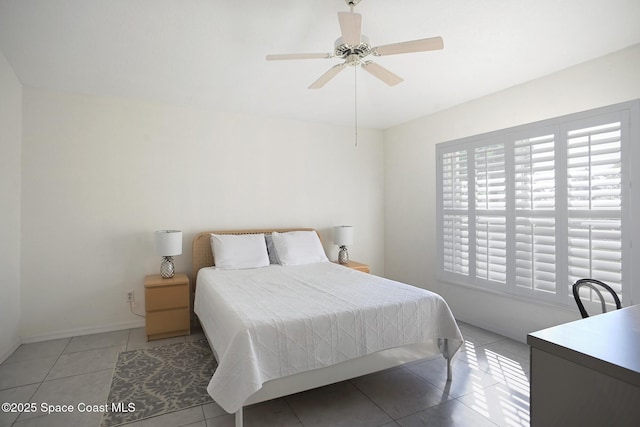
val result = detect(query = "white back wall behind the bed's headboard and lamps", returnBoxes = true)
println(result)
[21,87,384,341]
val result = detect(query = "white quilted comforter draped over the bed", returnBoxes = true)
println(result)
[194,262,462,412]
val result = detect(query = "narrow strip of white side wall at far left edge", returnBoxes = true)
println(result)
[0,52,22,362]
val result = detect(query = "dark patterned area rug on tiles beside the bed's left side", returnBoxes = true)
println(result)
[101,340,217,427]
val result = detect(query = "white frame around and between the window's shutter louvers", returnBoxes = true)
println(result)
[436,100,640,305]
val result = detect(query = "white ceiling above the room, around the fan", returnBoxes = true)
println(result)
[0,0,640,129]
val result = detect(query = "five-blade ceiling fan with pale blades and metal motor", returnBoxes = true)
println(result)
[267,0,444,89]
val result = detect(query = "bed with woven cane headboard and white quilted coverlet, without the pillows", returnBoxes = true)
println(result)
[193,228,463,427]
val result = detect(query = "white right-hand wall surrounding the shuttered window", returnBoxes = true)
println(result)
[384,45,640,341]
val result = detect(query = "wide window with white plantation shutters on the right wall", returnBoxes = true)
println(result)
[436,101,640,304]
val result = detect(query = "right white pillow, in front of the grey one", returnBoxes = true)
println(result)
[271,231,329,265]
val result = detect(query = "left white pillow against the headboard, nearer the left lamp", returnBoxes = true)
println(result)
[211,234,269,270]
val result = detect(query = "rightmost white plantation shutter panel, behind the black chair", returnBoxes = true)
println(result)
[567,121,622,303]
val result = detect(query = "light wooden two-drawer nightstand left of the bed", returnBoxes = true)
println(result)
[144,273,191,341]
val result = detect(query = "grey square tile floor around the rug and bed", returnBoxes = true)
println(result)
[0,323,529,427]
